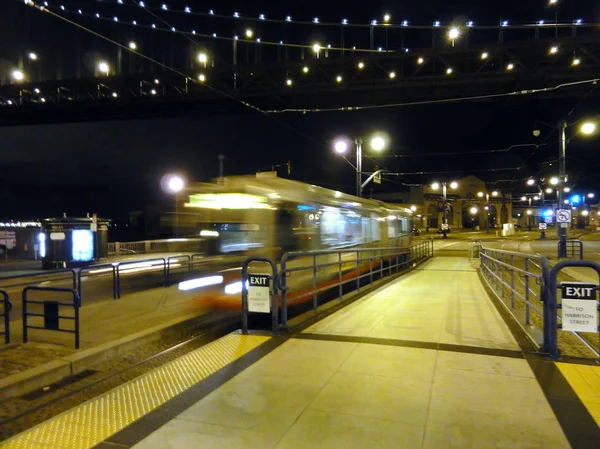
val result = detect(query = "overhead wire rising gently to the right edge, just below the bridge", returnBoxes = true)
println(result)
[267,78,600,114]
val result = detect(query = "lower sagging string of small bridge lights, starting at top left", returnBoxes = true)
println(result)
[39,1,394,53]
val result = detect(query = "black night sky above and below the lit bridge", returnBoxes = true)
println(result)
[0,0,600,222]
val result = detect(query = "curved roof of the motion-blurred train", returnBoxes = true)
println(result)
[187,172,412,215]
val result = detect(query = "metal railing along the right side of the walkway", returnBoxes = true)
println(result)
[479,247,550,351]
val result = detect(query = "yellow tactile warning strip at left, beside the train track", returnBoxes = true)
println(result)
[0,334,269,449]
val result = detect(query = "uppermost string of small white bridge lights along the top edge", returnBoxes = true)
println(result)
[77,0,598,30]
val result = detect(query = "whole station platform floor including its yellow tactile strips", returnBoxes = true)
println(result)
[0,257,600,449]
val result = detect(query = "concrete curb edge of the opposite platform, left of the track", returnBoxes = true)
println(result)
[0,315,211,401]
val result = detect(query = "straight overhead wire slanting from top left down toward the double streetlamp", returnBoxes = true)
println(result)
[28,2,332,151]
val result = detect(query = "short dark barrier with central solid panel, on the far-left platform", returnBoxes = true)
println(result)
[23,286,81,349]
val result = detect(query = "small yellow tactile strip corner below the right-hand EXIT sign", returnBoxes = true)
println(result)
[556,363,600,427]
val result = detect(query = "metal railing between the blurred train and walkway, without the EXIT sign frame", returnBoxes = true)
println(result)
[279,240,433,328]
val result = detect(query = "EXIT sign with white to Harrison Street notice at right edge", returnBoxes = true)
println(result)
[560,282,598,332]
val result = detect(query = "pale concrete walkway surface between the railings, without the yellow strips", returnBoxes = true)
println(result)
[125,257,571,449]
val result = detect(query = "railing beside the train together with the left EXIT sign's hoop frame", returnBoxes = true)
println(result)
[242,240,433,329]
